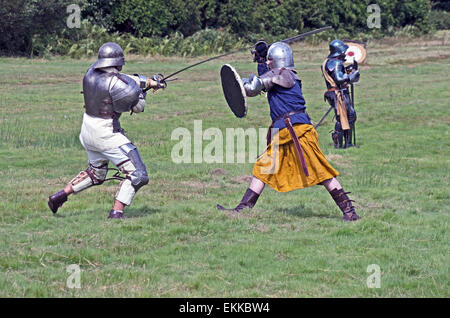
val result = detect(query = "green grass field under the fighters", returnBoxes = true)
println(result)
[0,40,450,297]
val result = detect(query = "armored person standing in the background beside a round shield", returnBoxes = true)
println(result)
[322,40,360,148]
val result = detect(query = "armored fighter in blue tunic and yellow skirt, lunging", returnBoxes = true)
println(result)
[217,42,359,221]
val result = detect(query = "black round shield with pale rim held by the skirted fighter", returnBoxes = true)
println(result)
[220,64,247,118]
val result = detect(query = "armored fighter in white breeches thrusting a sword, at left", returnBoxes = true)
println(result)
[48,42,166,218]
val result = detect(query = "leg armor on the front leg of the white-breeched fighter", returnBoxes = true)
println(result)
[116,144,149,205]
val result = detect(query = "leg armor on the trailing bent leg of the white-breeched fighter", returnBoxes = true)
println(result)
[70,161,108,193]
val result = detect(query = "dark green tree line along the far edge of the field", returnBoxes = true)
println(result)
[0,0,442,56]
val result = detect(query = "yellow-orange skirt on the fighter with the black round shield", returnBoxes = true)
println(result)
[252,124,339,192]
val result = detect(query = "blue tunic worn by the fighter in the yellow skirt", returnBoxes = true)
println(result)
[258,64,311,129]
